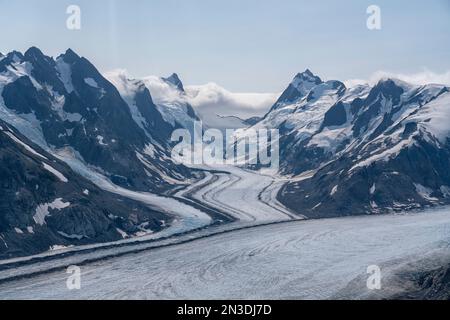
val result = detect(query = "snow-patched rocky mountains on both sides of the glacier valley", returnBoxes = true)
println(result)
[0,47,450,258]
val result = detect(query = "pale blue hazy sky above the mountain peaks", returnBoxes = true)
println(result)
[0,0,450,92]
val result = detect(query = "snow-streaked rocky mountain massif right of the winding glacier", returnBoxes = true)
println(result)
[243,70,450,218]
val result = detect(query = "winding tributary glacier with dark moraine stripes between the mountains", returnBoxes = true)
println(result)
[0,165,303,281]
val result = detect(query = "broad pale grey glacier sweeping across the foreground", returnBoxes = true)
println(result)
[0,208,450,299]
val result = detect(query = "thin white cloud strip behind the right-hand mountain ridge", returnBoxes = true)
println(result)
[344,69,450,87]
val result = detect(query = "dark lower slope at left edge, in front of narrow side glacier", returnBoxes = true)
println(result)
[0,120,171,259]
